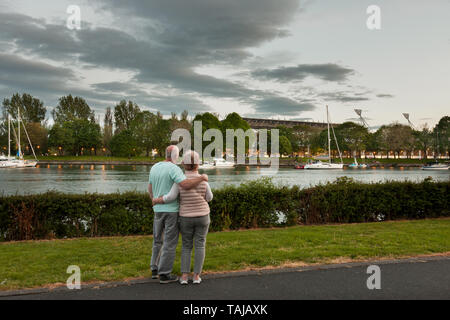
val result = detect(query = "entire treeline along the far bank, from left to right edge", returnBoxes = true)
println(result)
[0,93,450,158]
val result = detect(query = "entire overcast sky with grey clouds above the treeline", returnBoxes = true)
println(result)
[0,0,450,126]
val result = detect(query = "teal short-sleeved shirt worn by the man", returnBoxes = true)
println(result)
[148,161,186,212]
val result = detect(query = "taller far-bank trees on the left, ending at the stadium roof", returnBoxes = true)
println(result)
[0,94,250,157]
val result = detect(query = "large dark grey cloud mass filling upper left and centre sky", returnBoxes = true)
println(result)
[0,0,324,119]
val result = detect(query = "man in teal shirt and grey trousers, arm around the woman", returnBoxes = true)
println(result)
[148,145,208,283]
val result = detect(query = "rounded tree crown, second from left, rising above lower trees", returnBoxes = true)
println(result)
[52,95,95,124]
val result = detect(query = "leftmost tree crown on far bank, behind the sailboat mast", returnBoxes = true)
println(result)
[3,93,47,123]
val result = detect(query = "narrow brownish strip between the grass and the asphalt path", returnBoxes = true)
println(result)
[0,253,450,298]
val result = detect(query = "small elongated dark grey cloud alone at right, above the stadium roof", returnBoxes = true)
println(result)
[251,63,354,82]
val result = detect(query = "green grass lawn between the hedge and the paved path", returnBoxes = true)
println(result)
[0,218,450,290]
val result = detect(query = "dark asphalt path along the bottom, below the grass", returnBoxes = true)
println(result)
[0,257,450,300]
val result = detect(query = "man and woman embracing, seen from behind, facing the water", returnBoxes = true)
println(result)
[148,145,213,284]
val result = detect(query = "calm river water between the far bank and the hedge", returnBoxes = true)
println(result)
[0,165,450,194]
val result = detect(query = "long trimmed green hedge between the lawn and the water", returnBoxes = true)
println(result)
[0,177,450,241]
